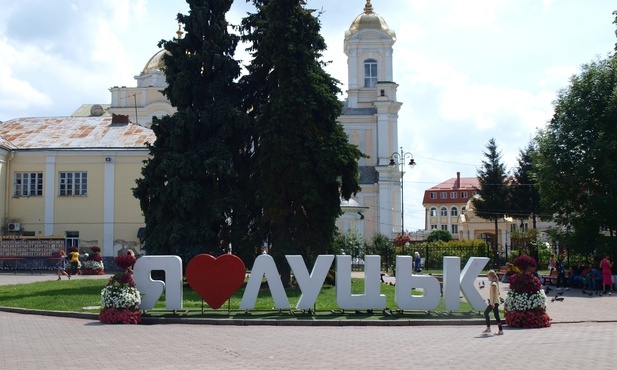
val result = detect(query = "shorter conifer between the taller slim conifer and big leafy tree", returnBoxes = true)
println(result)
[510,142,541,229]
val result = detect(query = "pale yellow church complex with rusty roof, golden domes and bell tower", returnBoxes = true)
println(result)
[0,0,402,256]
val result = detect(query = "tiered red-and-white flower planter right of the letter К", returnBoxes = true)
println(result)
[504,255,552,328]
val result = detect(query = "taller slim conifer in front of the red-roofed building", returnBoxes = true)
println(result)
[472,138,509,266]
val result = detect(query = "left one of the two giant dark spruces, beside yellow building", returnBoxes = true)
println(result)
[133,0,251,261]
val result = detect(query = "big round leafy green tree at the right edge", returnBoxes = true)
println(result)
[534,55,617,243]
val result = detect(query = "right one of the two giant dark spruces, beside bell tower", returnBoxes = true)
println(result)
[242,0,362,284]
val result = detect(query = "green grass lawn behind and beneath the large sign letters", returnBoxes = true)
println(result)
[0,278,478,318]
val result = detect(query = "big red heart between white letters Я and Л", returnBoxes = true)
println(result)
[186,254,246,310]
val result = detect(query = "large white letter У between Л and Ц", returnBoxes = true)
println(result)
[285,254,334,310]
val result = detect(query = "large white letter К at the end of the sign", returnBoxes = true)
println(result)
[443,257,489,311]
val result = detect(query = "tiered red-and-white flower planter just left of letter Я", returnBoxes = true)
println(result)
[99,255,141,324]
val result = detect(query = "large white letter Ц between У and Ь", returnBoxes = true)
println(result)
[336,256,386,310]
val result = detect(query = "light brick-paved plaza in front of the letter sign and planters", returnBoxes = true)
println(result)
[0,275,617,370]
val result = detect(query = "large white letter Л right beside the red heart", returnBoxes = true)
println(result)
[240,254,289,310]
